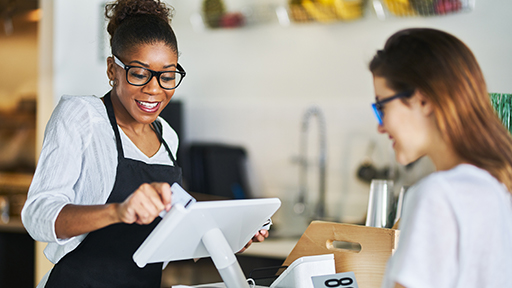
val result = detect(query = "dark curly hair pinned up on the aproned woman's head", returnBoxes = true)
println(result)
[105,0,178,56]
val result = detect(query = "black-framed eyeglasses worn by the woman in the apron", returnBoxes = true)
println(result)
[114,55,187,90]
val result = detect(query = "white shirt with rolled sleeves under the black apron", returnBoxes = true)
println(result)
[21,96,178,263]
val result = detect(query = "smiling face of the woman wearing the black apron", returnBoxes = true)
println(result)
[107,43,178,125]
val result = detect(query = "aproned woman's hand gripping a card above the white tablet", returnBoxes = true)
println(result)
[117,183,171,225]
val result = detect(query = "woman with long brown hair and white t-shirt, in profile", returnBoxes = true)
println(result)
[370,29,512,288]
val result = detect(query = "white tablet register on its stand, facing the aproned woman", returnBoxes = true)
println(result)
[133,198,281,288]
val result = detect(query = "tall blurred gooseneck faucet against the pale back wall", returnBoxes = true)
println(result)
[294,106,327,219]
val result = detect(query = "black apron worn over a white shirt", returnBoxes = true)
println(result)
[45,92,181,288]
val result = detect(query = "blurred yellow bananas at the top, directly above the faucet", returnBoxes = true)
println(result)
[301,0,363,23]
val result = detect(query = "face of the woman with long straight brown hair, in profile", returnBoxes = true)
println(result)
[374,76,432,165]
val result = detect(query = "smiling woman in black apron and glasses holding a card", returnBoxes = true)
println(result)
[22,0,268,288]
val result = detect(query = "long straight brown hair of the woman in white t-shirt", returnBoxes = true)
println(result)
[369,28,512,191]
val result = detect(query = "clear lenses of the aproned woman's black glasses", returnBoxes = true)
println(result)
[126,67,183,89]
